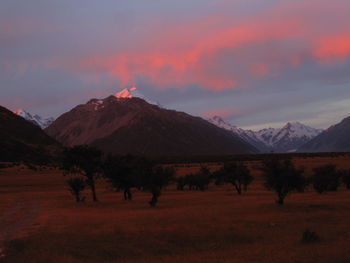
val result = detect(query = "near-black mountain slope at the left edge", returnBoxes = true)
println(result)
[0,106,60,162]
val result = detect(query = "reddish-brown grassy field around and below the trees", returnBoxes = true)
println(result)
[0,157,350,263]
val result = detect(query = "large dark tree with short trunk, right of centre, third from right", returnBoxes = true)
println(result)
[261,159,306,205]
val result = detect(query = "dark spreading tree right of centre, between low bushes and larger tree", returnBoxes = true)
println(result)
[215,162,254,195]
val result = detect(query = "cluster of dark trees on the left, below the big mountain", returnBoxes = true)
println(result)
[62,145,175,207]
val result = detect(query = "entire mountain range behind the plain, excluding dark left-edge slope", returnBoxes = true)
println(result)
[7,87,350,156]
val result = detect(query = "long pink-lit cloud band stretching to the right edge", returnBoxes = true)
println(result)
[13,0,350,91]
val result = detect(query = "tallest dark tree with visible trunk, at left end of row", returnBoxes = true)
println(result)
[62,145,102,202]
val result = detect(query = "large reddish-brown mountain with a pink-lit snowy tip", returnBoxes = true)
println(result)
[45,90,257,157]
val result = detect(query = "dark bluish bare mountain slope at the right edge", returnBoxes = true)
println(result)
[298,117,350,152]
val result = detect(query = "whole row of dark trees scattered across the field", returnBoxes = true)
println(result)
[61,145,350,207]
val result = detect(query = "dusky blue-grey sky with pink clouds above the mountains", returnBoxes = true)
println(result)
[0,0,350,130]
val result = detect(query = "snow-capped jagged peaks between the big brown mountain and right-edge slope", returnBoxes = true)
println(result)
[209,116,322,152]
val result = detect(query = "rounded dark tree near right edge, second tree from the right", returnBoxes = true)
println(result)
[311,164,342,194]
